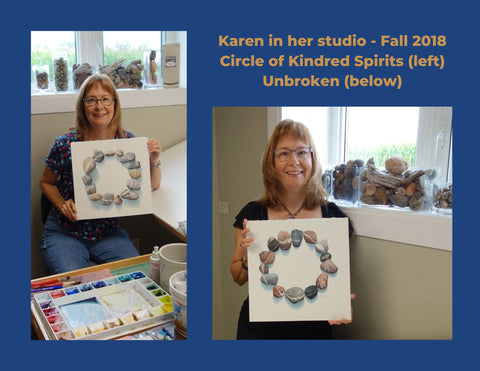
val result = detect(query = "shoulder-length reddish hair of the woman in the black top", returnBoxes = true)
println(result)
[261,119,328,210]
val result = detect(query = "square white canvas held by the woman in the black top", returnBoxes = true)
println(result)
[247,218,351,322]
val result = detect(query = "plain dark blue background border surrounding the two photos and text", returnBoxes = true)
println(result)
[0,0,479,370]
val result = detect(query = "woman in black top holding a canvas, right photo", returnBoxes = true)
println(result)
[230,120,354,339]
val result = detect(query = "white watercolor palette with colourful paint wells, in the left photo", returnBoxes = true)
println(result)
[33,272,173,340]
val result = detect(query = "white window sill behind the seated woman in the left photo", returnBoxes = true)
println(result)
[31,87,187,115]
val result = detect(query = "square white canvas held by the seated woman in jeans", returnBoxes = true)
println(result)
[71,138,152,220]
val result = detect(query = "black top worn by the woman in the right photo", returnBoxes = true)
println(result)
[233,201,353,339]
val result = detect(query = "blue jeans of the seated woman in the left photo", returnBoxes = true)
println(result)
[40,213,139,274]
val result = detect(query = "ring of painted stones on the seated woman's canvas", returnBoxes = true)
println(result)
[82,149,142,206]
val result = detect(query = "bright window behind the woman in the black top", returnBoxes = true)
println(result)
[281,107,452,182]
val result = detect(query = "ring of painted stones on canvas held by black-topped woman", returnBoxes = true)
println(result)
[259,229,338,304]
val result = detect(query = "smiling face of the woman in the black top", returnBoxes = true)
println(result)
[274,136,312,190]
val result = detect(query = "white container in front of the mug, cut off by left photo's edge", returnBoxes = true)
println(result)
[169,270,187,338]
